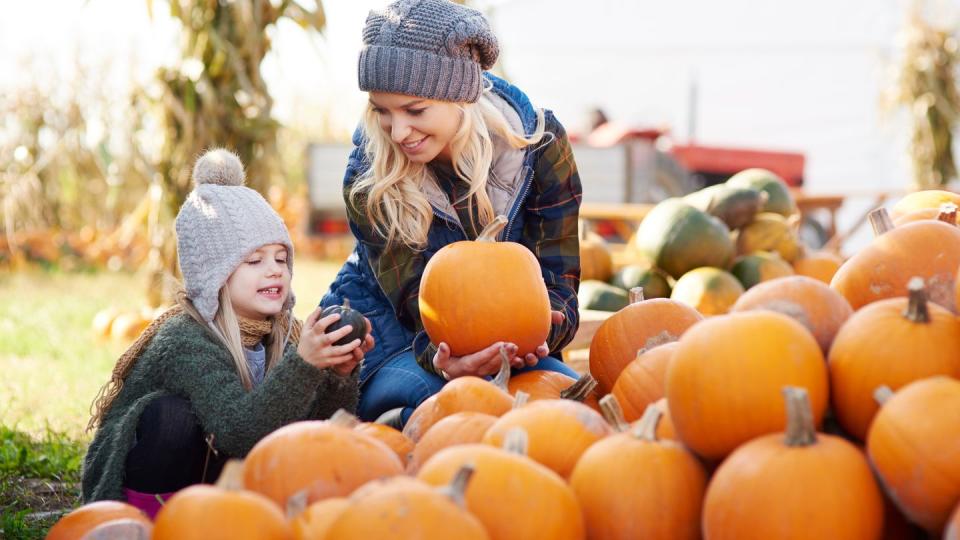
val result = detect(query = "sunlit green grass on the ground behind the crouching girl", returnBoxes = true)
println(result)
[0,259,340,539]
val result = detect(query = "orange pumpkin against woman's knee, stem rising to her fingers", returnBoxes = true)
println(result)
[403,356,513,443]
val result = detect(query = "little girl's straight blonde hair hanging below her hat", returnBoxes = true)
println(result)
[177,285,292,390]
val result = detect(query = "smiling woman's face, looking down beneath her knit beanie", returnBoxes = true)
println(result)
[370,92,460,163]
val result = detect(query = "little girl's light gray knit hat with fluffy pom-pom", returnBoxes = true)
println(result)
[176,149,294,323]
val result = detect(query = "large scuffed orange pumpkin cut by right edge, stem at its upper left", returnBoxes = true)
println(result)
[830,208,960,311]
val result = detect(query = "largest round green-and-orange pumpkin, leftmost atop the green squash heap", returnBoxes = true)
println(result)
[634,199,734,278]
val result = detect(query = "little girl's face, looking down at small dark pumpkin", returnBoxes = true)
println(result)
[227,244,290,320]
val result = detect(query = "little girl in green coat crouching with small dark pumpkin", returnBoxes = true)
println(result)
[83,150,373,517]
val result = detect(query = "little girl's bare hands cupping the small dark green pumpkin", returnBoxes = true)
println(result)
[297,308,362,375]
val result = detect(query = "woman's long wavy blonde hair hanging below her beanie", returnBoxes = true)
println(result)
[349,89,544,249]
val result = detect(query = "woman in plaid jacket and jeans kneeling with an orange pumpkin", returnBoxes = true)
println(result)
[321,0,581,425]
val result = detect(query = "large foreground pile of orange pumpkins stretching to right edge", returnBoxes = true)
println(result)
[54,188,960,540]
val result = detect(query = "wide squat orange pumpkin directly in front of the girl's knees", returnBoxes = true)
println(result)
[243,420,403,508]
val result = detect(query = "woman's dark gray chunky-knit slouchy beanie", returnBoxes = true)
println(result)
[359,0,500,103]
